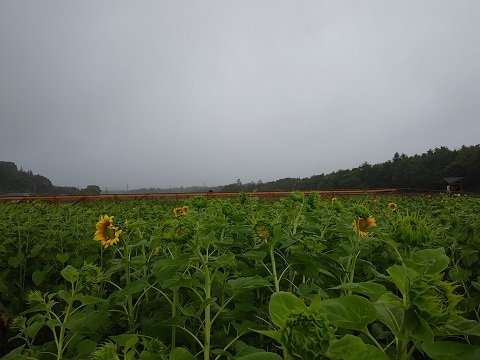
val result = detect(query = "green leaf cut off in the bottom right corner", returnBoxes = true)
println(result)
[422,341,480,360]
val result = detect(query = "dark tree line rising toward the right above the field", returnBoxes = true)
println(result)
[222,145,480,193]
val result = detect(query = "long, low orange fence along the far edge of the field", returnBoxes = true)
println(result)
[0,189,398,204]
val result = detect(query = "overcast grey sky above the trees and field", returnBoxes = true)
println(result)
[0,0,480,189]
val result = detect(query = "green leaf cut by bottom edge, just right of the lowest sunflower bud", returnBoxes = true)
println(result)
[326,334,389,360]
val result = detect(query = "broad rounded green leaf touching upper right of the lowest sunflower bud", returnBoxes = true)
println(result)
[320,295,377,330]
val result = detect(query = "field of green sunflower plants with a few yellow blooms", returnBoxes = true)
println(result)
[0,192,480,360]
